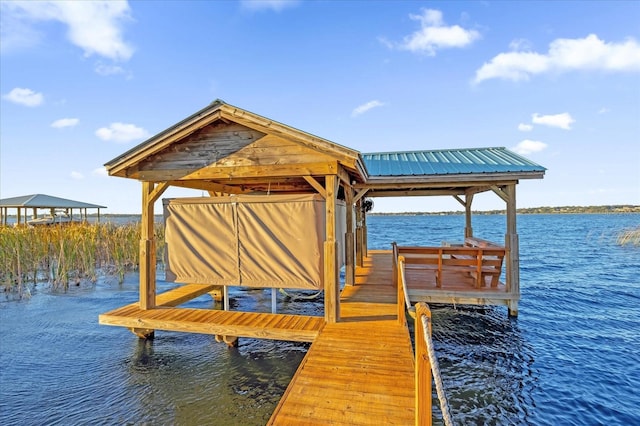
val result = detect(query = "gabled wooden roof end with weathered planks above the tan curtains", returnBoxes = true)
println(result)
[105,100,366,192]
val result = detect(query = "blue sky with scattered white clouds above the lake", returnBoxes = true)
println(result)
[0,0,640,213]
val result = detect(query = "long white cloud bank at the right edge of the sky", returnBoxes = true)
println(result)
[474,34,640,83]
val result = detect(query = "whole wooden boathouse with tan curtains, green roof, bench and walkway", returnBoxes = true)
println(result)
[99,100,545,424]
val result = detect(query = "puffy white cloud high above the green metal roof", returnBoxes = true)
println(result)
[396,9,480,56]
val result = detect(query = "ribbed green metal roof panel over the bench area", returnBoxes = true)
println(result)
[362,148,546,176]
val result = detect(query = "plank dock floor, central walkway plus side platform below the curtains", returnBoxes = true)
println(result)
[99,251,415,425]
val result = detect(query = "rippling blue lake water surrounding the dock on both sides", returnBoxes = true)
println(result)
[0,214,640,425]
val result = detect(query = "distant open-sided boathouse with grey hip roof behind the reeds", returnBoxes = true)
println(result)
[0,194,107,225]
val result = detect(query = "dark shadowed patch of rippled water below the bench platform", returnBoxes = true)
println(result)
[424,305,535,425]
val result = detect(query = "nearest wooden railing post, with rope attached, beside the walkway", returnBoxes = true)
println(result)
[415,302,433,426]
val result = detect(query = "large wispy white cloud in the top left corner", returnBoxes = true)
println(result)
[2,0,133,61]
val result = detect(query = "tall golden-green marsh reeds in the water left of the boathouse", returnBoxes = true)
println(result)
[0,223,164,296]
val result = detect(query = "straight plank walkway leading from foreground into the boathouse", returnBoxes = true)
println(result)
[268,251,415,425]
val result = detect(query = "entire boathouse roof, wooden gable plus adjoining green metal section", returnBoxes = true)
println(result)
[105,100,545,196]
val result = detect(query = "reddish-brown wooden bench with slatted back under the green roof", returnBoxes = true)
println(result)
[393,241,505,288]
